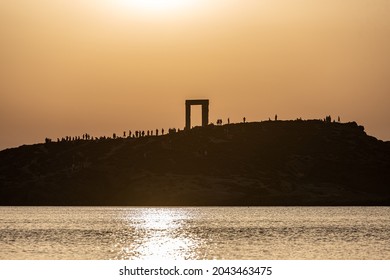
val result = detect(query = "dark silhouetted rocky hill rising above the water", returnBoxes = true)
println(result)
[0,120,390,206]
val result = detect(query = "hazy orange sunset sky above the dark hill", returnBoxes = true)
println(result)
[0,0,390,150]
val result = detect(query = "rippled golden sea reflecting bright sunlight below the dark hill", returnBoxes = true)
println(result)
[0,207,390,259]
